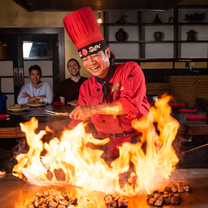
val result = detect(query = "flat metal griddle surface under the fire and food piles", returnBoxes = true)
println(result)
[0,169,208,208]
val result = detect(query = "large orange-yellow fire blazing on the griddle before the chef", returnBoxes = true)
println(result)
[13,96,179,200]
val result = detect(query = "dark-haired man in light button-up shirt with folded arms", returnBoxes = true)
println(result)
[17,65,53,105]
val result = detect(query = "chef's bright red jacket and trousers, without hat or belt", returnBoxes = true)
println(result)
[68,62,150,157]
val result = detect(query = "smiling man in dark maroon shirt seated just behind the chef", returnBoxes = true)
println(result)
[58,58,87,104]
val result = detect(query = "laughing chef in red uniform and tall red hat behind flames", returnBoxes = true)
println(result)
[63,7,150,160]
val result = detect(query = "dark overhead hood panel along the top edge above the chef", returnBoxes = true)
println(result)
[13,0,182,12]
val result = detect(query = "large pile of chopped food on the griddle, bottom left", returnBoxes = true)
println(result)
[27,189,77,208]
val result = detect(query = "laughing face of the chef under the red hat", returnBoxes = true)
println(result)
[82,48,110,78]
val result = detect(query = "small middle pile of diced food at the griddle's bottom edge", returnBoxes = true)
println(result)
[104,194,128,208]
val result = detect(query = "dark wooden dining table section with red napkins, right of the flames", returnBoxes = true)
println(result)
[171,103,208,135]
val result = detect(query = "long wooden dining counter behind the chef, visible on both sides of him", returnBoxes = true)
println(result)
[0,103,208,139]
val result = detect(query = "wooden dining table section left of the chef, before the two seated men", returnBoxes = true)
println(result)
[0,105,75,139]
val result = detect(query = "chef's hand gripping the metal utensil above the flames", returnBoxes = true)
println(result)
[69,105,93,120]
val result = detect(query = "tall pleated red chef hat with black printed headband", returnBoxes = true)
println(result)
[63,7,107,58]
